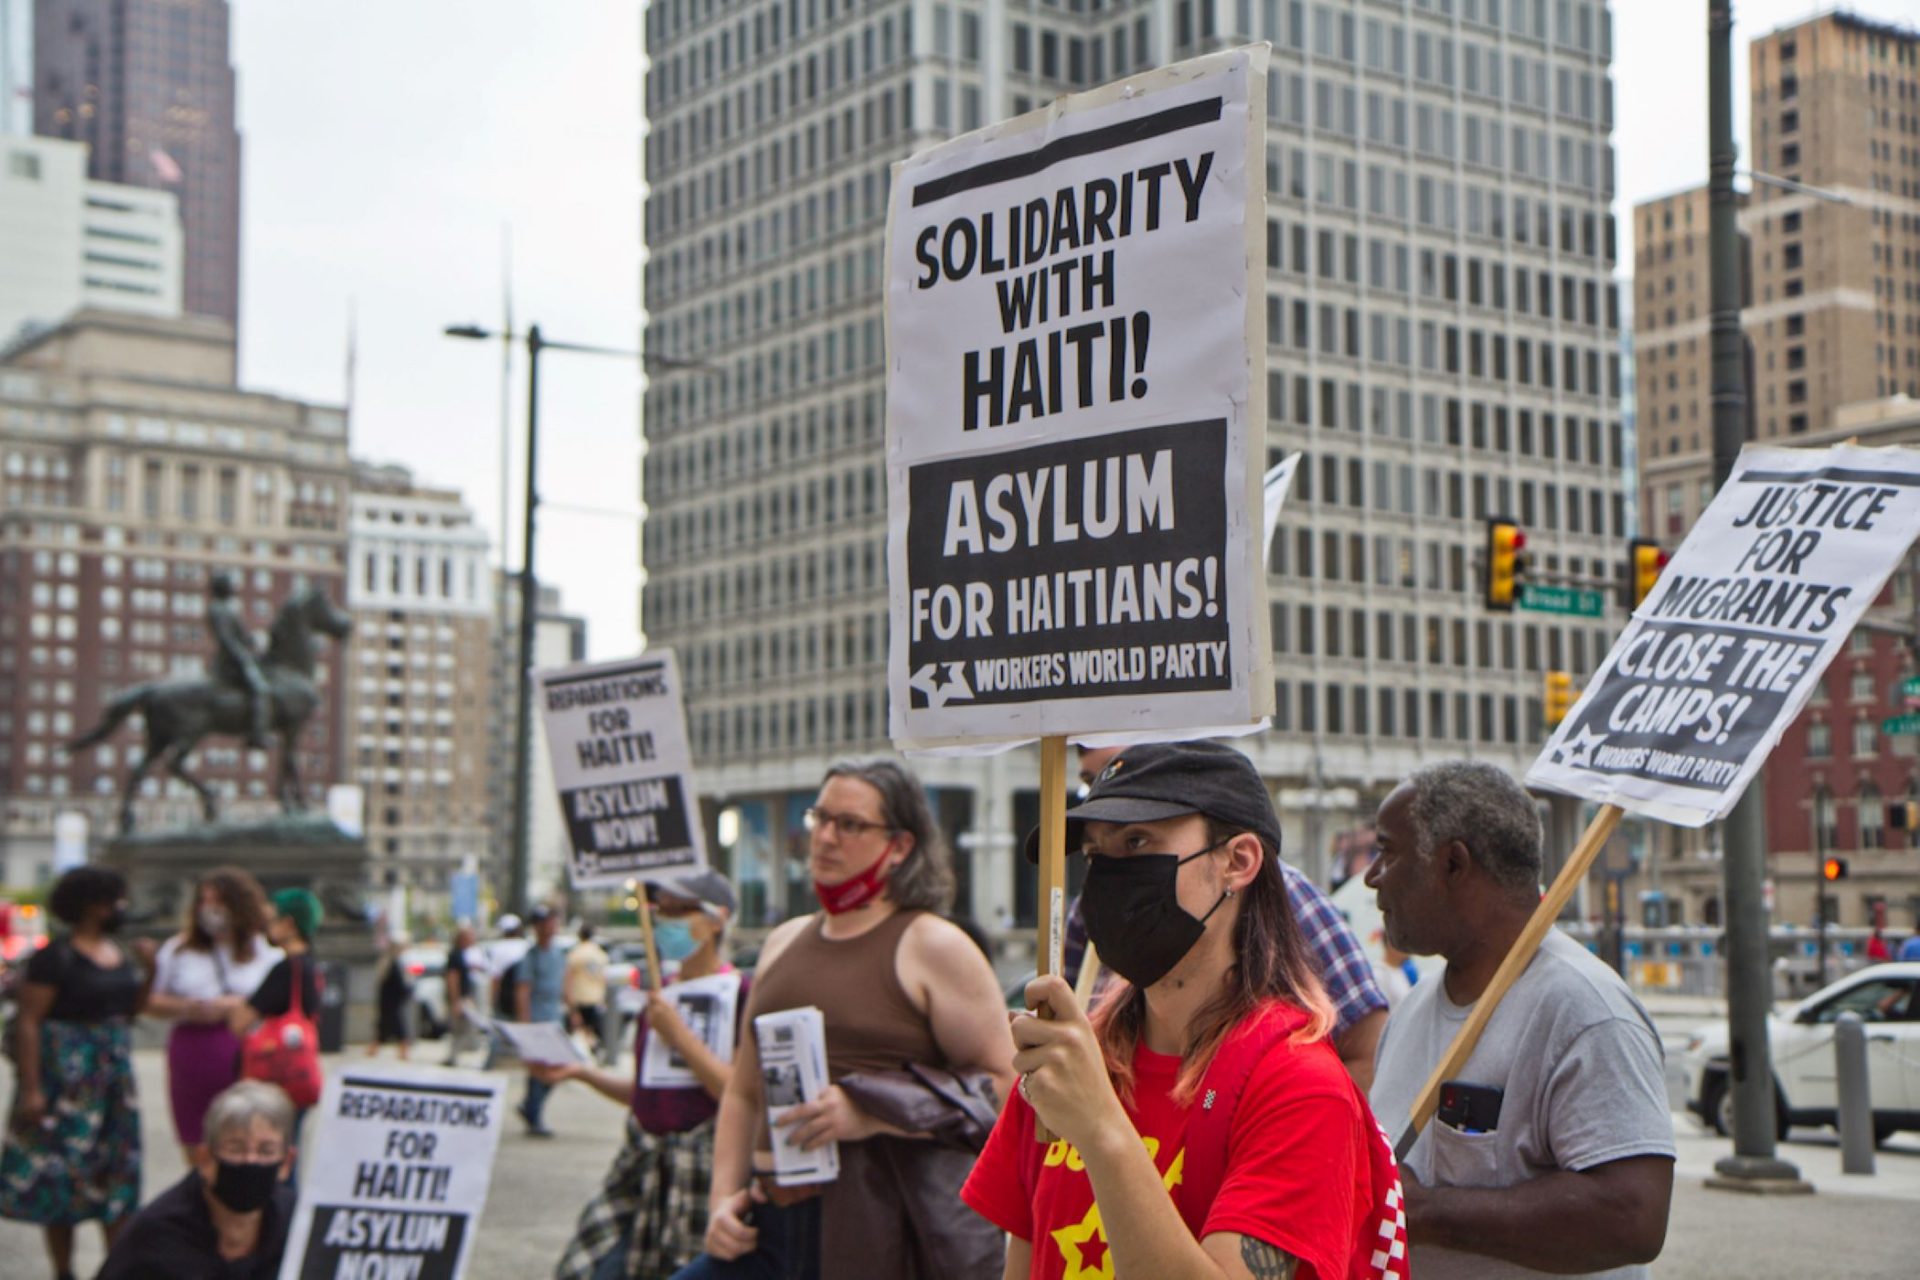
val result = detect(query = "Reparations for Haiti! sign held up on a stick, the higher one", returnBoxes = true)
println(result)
[534,651,707,889]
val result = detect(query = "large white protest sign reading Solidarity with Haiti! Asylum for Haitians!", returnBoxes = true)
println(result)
[887,46,1273,748]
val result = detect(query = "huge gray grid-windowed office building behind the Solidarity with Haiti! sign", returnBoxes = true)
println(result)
[643,0,1624,925]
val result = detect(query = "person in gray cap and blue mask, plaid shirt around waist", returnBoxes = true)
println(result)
[549,871,747,1280]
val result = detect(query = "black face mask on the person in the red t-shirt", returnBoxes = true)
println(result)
[1081,837,1231,986]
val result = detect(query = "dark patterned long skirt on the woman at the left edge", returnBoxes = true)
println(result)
[0,1019,140,1226]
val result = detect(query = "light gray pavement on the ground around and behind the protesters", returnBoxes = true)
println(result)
[0,1043,1920,1280]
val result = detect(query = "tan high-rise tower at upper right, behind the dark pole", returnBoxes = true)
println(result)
[1634,12,1920,537]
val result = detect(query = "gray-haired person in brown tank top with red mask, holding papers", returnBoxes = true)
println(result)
[674,760,1014,1280]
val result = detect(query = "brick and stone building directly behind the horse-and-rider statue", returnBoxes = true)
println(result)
[0,311,353,885]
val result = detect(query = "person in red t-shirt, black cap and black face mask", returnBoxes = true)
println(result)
[962,743,1407,1280]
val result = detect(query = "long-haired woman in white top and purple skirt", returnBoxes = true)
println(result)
[144,867,280,1159]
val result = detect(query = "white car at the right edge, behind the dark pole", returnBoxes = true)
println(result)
[1680,961,1920,1142]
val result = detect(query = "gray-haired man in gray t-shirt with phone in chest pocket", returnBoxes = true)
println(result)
[1367,762,1674,1280]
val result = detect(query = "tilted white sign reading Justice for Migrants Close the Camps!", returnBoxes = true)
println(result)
[1526,445,1920,827]
